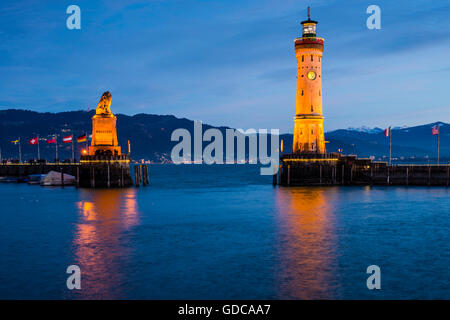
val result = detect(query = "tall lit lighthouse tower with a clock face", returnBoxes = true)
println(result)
[292,7,326,154]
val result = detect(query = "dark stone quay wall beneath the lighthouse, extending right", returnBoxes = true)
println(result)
[273,153,450,187]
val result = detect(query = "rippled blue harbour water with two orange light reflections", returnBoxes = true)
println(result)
[0,165,450,299]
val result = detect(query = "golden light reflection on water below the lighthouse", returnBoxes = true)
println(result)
[276,188,336,299]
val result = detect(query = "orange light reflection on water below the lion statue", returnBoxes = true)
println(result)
[73,189,139,299]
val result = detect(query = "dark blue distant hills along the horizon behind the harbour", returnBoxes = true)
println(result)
[0,109,450,162]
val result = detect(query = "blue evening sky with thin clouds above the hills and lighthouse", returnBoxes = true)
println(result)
[0,0,450,132]
